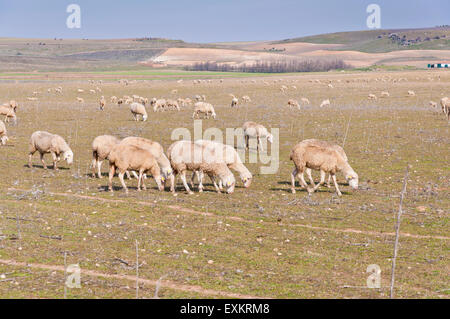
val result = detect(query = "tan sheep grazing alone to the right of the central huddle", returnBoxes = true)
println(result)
[290,141,358,196]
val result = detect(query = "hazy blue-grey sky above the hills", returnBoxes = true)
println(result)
[0,0,450,42]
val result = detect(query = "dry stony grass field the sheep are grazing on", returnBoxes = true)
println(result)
[0,71,450,298]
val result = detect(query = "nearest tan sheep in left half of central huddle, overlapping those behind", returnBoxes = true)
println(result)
[108,144,163,194]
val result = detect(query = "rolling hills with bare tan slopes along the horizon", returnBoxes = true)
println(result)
[0,26,450,72]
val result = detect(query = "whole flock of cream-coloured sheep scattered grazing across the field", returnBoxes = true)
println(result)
[0,79,450,196]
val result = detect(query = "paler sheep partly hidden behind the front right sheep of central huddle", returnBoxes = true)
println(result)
[196,140,253,188]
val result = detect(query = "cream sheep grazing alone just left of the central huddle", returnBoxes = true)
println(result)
[28,131,73,170]
